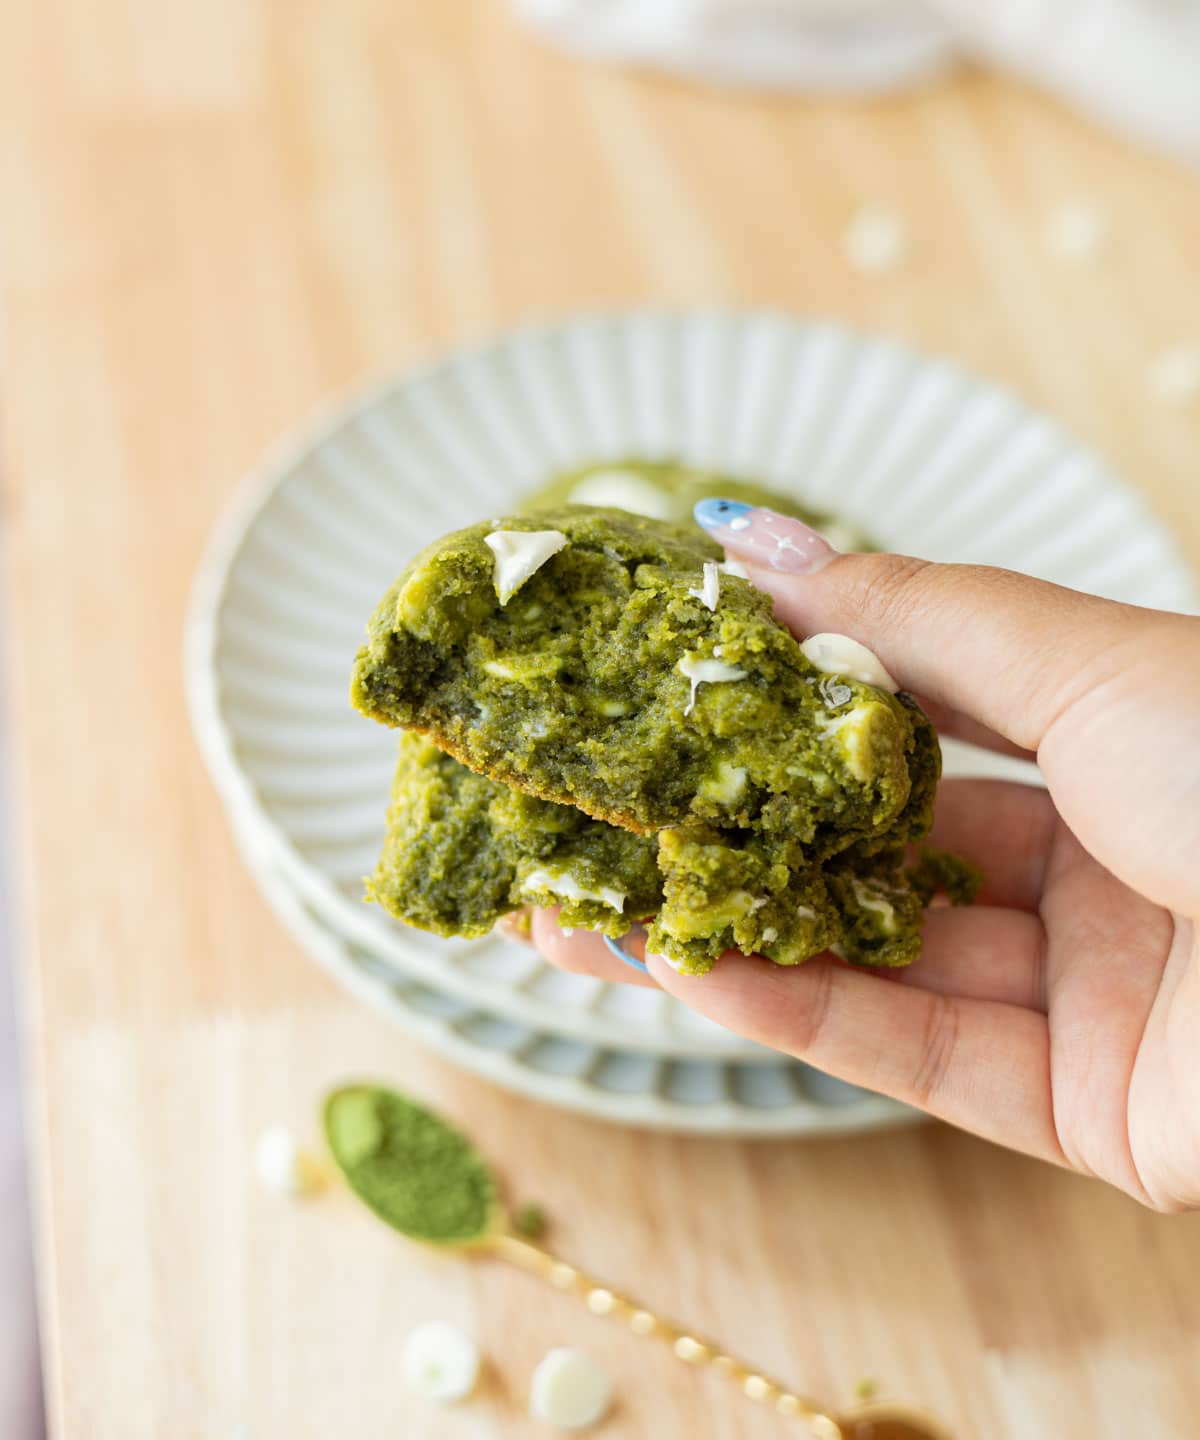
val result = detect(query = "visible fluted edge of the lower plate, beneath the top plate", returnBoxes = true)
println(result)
[238,812,923,1136]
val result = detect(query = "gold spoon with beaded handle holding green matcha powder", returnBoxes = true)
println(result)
[324,1084,951,1440]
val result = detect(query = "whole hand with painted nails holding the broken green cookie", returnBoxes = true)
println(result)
[533,501,1200,1210]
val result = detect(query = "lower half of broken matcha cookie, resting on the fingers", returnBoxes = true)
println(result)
[367,732,967,973]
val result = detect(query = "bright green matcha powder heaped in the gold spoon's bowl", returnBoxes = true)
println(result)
[326,1086,497,1244]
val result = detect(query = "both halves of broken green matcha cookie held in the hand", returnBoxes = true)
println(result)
[353,505,971,973]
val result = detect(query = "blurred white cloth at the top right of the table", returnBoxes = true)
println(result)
[514,0,1200,160]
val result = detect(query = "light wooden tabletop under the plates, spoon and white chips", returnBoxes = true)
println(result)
[0,0,1200,1440]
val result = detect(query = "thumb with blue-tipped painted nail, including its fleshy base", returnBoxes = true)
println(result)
[696,500,1200,913]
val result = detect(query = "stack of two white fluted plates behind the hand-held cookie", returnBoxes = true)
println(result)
[186,311,1196,1135]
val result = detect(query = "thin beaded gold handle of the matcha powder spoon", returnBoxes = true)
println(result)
[490,1233,846,1440]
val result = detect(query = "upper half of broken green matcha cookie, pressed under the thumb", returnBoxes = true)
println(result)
[353,507,916,861]
